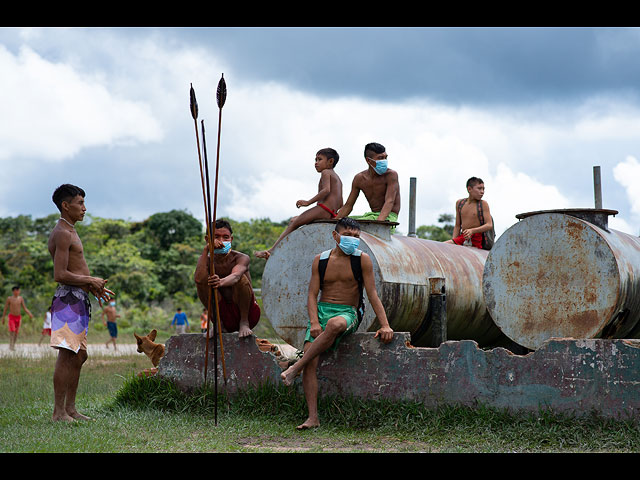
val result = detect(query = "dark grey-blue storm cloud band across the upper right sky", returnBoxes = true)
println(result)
[171,27,640,104]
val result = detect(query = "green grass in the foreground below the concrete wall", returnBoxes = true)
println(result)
[0,355,640,453]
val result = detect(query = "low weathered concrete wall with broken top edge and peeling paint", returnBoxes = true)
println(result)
[159,332,640,418]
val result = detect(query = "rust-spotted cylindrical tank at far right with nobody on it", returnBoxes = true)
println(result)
[483,209,640,350]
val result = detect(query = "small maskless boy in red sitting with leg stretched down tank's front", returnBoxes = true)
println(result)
[253,148,342,260]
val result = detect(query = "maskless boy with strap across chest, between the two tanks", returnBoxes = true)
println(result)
[446,177,493,250]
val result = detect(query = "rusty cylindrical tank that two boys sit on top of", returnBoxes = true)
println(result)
[262,221,509,348]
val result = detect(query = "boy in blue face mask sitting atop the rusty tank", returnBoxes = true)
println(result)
[337,143,400,233]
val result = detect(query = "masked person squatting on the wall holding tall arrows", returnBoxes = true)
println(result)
[194,219,260,338]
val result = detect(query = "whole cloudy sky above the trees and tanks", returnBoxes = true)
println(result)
[0,27,640,235]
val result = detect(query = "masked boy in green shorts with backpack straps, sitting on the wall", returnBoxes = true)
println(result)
[281,218,393,430]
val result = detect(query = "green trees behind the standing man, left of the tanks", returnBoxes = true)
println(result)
[0,210,288,318]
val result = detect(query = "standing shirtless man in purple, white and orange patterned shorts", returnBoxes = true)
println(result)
[48,184,113,421]
